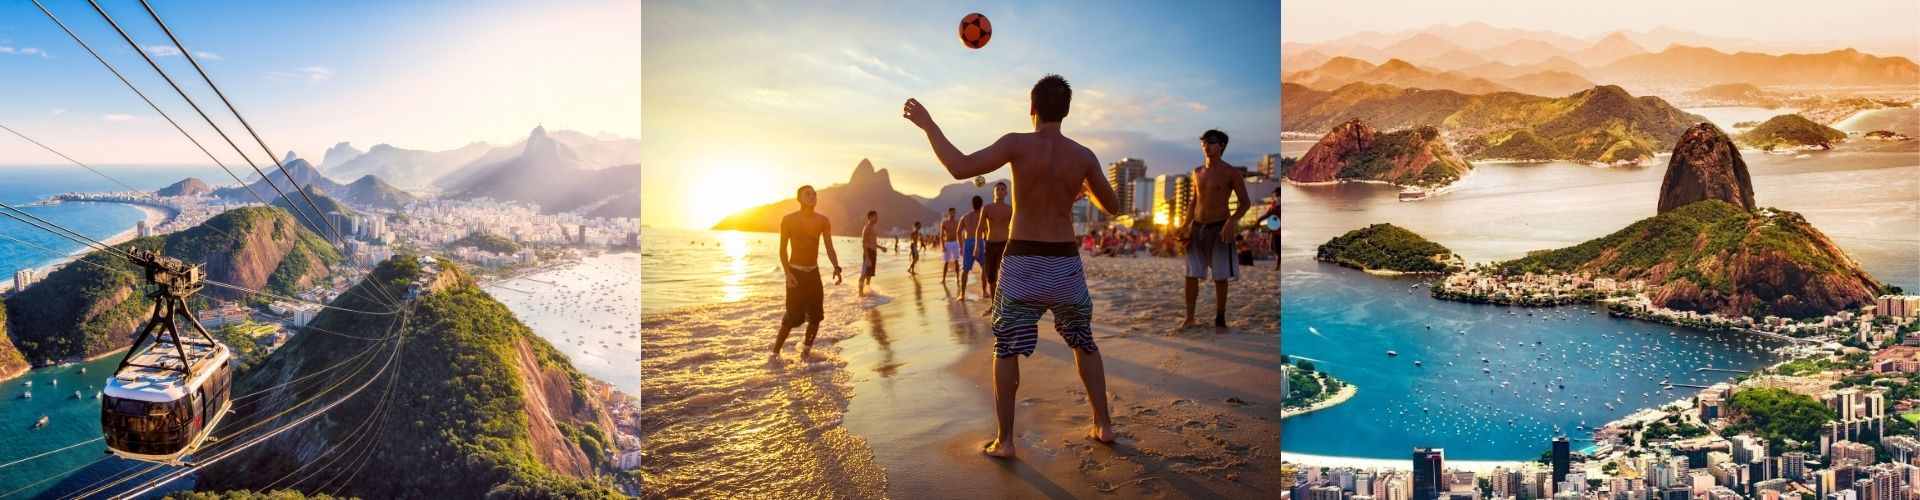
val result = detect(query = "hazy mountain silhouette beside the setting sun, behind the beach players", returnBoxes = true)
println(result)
[712,160,939,235]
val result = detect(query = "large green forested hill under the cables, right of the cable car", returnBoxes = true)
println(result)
[196,256,618,498]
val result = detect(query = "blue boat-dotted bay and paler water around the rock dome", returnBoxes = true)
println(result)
[1281,110,1920,460]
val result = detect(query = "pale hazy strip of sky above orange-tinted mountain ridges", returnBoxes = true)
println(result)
[1281,0,1920,54]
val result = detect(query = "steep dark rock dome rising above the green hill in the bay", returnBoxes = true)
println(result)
[1655,121,1755,213]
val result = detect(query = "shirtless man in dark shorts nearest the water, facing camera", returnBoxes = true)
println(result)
[774,187,841,358]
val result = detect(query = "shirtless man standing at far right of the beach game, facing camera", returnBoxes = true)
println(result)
[1179,131,1254,329]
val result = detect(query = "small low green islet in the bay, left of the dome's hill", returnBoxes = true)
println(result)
[1313,223,1457,273]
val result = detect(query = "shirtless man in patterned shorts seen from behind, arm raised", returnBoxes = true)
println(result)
[902,75,1119,458]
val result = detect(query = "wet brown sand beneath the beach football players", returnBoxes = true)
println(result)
[841,256,1281,498]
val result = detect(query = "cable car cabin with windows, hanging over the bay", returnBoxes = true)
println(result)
[100,342,232,463]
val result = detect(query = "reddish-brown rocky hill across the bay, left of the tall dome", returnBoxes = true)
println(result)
[1286,119,1473,187]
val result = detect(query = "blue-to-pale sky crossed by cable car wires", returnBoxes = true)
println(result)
[0,0,641,168]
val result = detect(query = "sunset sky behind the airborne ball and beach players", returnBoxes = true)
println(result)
[641,2,1279,229]
